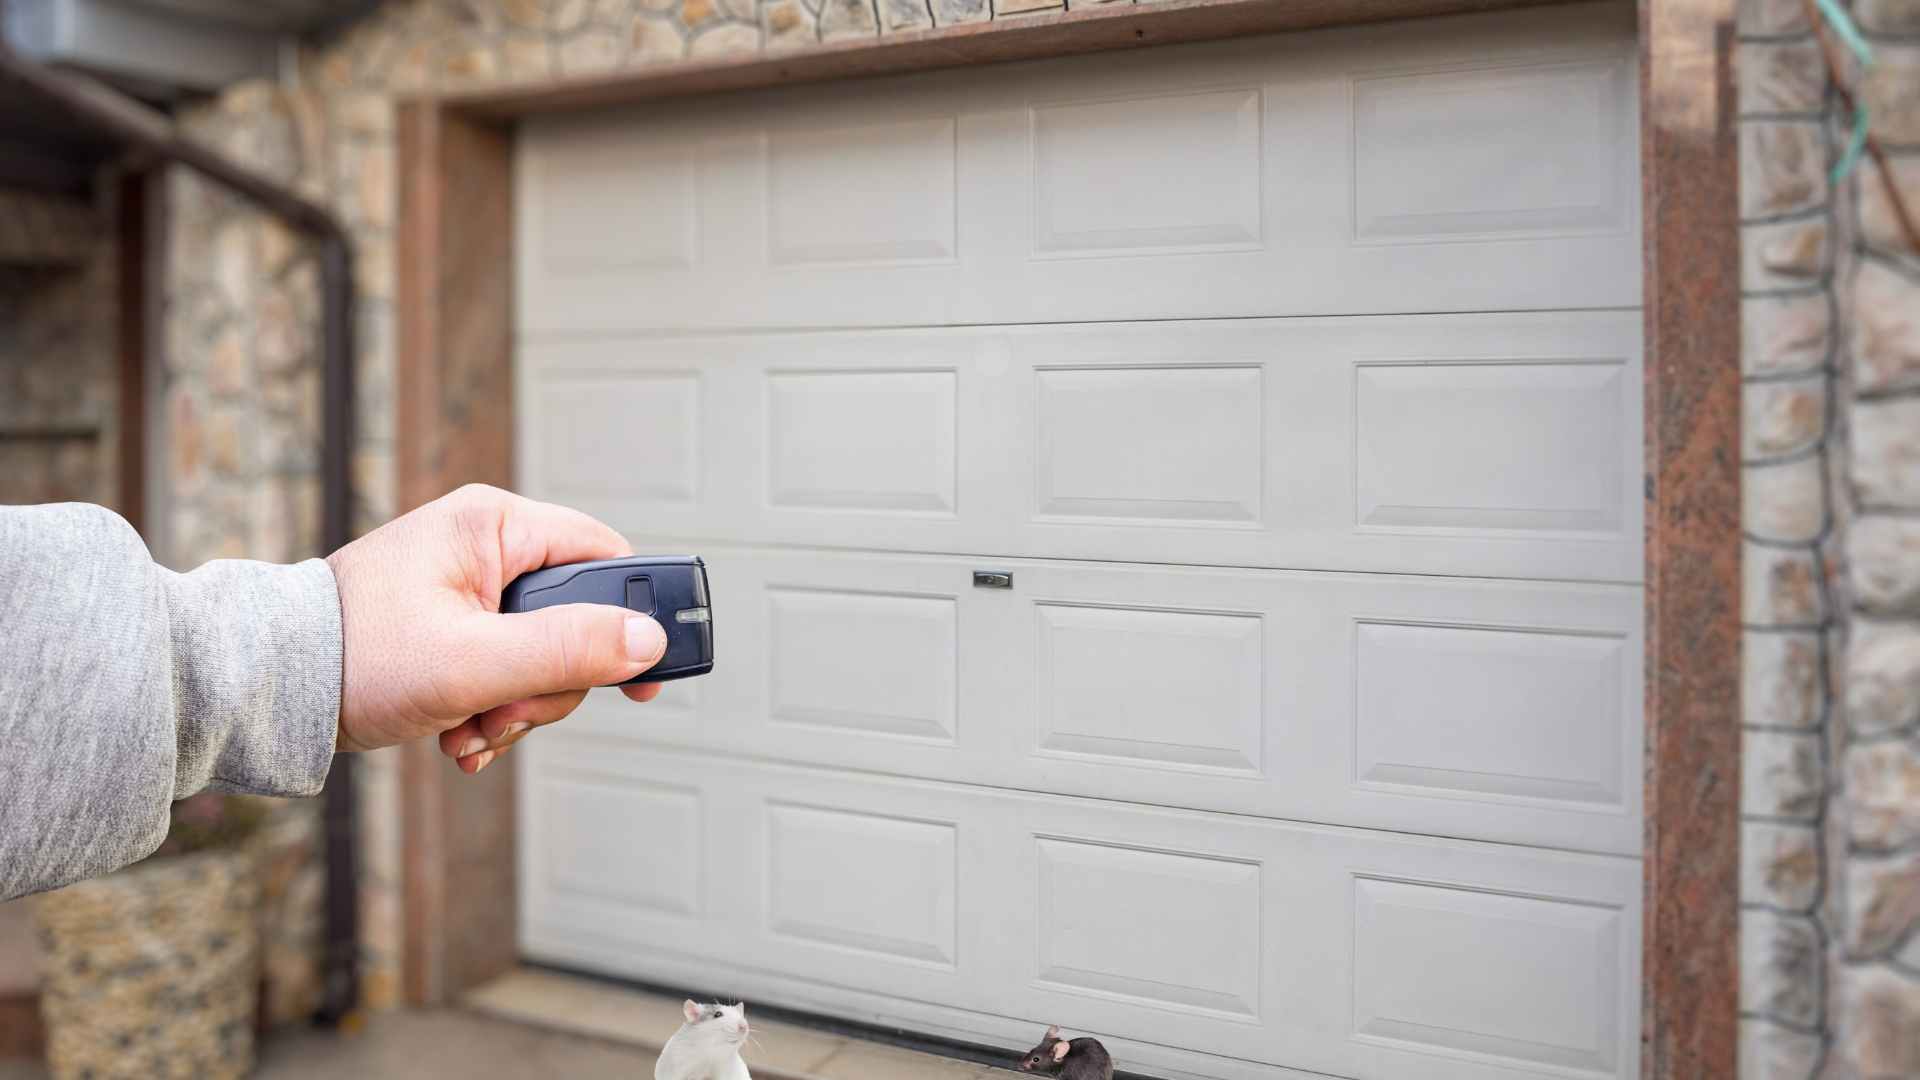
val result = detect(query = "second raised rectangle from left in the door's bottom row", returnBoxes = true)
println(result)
[766,803,958,967]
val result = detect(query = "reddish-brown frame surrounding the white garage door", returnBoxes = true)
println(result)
[397,0,1741,1080]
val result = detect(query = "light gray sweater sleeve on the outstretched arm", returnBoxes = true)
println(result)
[0,503,342,899]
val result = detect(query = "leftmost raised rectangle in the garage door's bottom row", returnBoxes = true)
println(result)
[536,773,707,915]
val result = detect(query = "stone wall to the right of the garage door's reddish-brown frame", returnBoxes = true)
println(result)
[1738,0,1920,1080]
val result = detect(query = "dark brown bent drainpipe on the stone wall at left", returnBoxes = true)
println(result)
[0,42,359,1022]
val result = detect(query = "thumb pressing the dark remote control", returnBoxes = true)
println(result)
[467,603,666,707]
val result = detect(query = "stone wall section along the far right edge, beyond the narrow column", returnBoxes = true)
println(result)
[1830,0,1920,1078]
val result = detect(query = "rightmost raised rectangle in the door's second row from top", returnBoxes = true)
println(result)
[1354,359,1640,534]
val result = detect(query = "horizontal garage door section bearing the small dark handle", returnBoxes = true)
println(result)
[574,536,1642,853]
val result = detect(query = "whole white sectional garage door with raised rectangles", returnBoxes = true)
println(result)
[518,6,1642,1080]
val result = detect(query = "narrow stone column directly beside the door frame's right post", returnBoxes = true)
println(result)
[1738,0,1837,1080]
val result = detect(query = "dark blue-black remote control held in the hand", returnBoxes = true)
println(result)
[499,555,714,682]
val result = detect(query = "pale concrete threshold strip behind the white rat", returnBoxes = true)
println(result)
[461,969,1014,1080]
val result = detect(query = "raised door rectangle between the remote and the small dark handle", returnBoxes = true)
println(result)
[768,588,958,742]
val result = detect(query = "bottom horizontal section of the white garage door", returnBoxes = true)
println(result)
[524,728,1640,1078]
